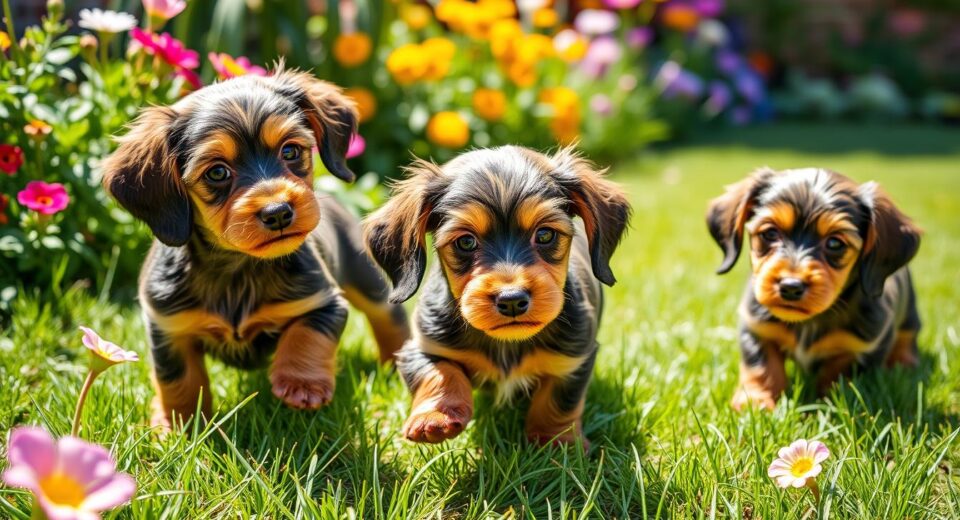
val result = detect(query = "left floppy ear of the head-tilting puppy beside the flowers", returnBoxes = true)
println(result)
[103,107,193,246]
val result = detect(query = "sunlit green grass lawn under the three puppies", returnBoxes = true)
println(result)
[0,127,960,519]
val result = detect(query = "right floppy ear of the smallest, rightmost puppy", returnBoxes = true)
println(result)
[857,182,921,298]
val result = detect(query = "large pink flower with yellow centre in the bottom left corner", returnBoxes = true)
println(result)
[3,426,137,520]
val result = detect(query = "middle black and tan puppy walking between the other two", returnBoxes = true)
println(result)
[364,146,630,443]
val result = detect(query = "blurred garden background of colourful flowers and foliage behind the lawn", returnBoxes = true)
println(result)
[0,0,960,312]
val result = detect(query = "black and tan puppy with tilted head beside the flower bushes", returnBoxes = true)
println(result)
[103,71,409,427]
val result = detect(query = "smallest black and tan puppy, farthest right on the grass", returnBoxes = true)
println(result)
[707,168,920,410]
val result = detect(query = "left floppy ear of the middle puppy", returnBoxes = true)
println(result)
[363,159,444,303]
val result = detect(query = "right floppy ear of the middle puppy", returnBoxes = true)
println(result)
[553,147,631,285]
